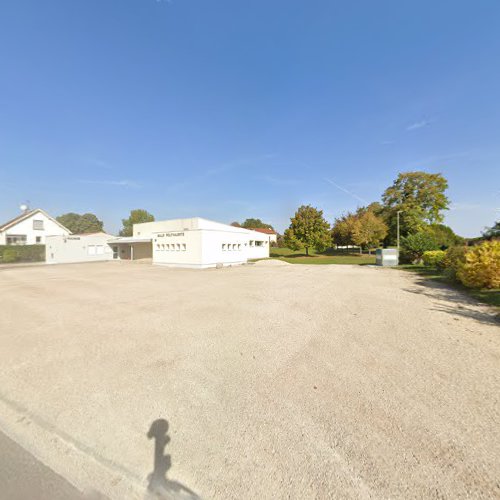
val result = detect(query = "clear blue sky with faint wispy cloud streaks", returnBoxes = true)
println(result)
[0,0,500,236]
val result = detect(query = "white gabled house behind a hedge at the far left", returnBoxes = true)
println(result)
[0,208,71,245]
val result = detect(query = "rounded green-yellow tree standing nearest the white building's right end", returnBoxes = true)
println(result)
[284,205,331,255]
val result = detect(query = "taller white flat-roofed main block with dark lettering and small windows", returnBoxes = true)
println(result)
[134,217,269,268]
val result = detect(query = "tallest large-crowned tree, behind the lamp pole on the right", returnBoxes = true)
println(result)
[382,171,449,242]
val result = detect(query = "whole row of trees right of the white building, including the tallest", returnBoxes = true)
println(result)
[284,171,470,255]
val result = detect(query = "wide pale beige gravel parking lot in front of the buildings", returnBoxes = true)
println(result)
[0,262,500,499]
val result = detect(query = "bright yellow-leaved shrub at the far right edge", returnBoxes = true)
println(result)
[457,241,500,288]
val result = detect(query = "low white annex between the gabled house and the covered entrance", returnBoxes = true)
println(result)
[45,233,115,264]
